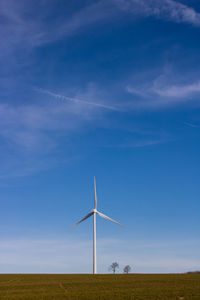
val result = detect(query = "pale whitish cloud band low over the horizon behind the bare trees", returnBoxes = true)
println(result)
[0,236,200,273]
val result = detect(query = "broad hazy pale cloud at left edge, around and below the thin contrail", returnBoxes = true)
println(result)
[0,84,118,178]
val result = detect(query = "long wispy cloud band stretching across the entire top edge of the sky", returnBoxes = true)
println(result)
[0,0,200,61]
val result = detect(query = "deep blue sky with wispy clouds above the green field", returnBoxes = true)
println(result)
[0,0,200,273]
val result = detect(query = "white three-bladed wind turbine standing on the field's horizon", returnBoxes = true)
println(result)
[71,177,123,274]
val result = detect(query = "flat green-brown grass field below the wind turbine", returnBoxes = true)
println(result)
[0,274,200,300]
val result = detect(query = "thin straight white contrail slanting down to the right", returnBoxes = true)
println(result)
[35,88,119,111]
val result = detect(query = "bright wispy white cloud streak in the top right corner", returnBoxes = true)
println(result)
[114,0,200,26]
